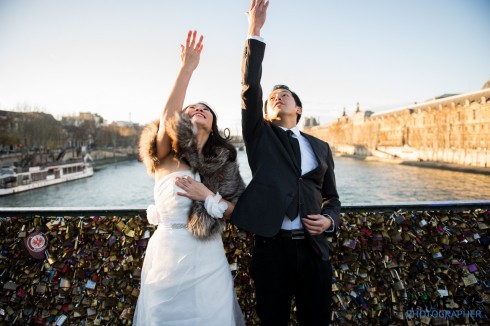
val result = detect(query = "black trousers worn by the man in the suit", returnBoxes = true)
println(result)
[250,236,332,326]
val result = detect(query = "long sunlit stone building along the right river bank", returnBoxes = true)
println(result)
[305,81,490,167]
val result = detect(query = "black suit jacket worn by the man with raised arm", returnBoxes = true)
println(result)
[231,39,340,260]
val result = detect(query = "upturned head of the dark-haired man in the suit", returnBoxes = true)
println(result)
[266,88,301,121]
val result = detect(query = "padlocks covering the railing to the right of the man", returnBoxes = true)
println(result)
[332,209,490,325]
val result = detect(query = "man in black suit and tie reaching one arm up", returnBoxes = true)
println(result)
[231,0,340,326]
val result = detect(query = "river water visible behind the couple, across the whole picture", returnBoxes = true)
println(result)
[0,152,490,208]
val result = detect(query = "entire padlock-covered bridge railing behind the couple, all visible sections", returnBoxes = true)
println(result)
[0,201,490,325]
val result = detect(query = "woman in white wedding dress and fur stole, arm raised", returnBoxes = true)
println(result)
[133,31,245,326]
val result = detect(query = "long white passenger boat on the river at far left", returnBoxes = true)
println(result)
[0,161,94,196]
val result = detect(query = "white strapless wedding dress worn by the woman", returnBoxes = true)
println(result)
[133,170,245,326]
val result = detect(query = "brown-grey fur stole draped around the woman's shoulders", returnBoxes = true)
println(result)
[139,113,245,240]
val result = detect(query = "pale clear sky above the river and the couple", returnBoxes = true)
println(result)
[0,0,490,132]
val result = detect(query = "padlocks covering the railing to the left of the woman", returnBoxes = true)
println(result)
[0,216,151,325]
